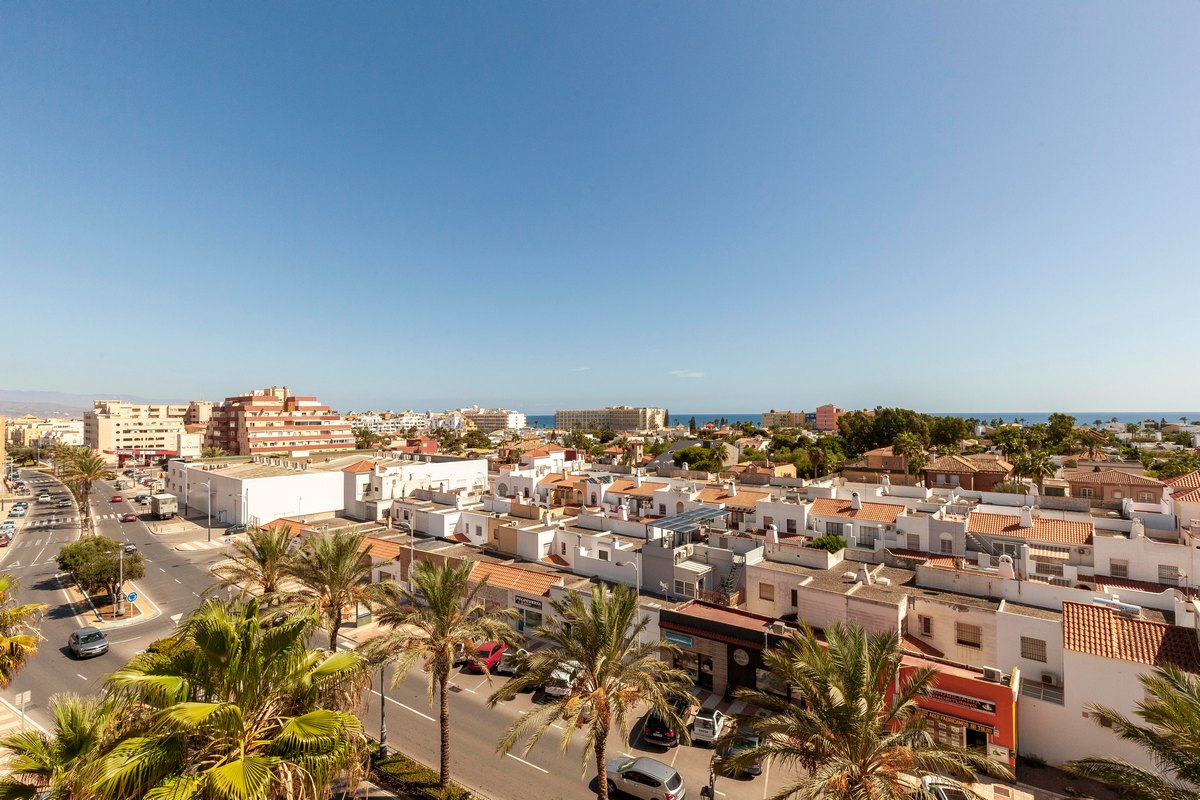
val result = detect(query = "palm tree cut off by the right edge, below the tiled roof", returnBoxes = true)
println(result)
[1063,664,1200,800]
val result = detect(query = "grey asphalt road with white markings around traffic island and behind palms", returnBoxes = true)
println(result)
[0,470,782,800]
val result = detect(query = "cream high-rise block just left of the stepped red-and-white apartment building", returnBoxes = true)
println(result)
[83,401,188,463]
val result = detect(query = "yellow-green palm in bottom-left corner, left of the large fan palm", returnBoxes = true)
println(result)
[0,694,119,800]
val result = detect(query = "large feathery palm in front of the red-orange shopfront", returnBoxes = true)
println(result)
[721,625,1010,800]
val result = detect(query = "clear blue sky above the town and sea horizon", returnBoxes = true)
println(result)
[0,1,1200,414]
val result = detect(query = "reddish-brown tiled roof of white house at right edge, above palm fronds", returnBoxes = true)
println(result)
[1062,602,1200,673]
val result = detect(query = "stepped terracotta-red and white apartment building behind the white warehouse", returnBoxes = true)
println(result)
[204,386,354,456]
